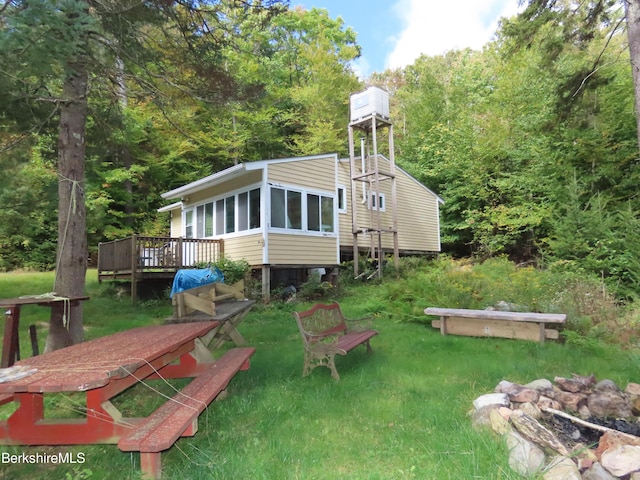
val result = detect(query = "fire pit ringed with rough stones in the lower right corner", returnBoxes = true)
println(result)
[472,375,640,480]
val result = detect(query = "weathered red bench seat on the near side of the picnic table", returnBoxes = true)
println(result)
[118,348,255,479]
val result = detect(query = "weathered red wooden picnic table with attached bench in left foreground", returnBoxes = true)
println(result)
[0,322,255,478]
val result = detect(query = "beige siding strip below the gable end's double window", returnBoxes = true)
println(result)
[267,233,338,265]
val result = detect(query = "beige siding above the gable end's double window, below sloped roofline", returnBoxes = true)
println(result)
[267,156,336,192]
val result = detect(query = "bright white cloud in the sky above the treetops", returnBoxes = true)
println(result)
[386,0,518,68]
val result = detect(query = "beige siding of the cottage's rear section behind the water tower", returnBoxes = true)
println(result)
[338,159,440,252]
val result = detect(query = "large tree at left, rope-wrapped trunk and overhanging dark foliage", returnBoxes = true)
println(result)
[0,0,280,349]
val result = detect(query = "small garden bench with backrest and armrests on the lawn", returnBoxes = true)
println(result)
[293,302,378,380]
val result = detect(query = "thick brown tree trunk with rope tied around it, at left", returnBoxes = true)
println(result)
[45,62,88,351]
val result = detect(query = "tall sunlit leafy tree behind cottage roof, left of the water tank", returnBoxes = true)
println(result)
[212,7,360,159]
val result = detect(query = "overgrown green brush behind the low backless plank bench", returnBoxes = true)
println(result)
[336,256,640,347]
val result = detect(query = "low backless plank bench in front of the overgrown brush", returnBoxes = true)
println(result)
[424,307,567,343]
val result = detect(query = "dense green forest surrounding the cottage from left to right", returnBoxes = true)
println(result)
[0,0,640,300]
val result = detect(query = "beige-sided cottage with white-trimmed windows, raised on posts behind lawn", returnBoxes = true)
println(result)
[159,154,442,295]
